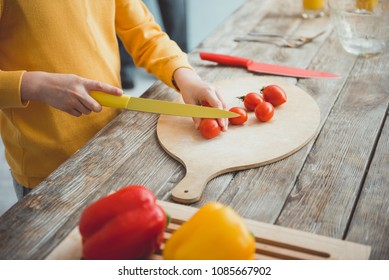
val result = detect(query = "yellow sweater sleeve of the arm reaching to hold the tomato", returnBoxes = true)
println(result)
[115,0,193,90]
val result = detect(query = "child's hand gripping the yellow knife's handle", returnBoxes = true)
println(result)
[21,72,123,117]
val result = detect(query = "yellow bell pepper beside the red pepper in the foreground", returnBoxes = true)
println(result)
[163,202,255,260]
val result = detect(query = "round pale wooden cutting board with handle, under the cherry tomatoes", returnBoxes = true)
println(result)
[157,76,320,203]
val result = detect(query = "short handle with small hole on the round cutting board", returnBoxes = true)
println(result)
[172,170,209,204]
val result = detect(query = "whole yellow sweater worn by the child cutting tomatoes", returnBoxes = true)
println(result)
[0,0,190,188]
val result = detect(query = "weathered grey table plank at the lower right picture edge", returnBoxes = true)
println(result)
[346,110,389,260]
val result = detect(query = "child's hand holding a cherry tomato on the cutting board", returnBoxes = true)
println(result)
[174,68,228,131]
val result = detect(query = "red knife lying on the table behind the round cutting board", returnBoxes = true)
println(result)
[200,52,340,78]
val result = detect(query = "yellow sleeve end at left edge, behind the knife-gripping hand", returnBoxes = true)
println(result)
[0,70,26,109]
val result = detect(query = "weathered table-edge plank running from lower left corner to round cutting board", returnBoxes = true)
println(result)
[0,76,189,259]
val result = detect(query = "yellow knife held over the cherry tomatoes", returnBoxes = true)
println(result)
[90,91,239,119]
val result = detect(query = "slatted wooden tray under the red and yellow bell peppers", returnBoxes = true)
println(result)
[46,201,370,260]
